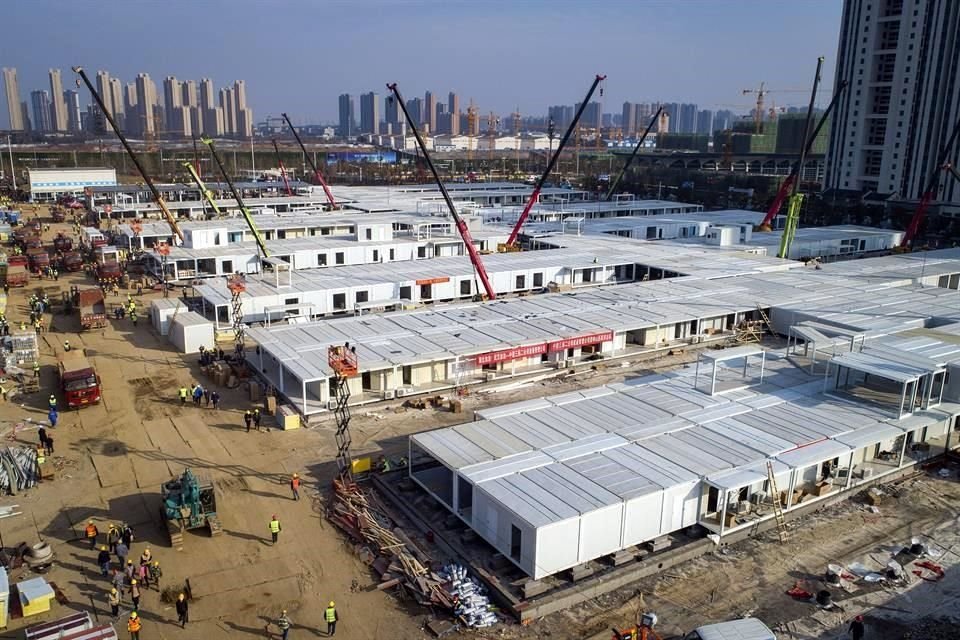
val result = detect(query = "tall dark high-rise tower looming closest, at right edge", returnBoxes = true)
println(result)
[824,0,960,205]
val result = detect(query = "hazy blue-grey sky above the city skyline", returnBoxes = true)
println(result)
[0,0,842,127]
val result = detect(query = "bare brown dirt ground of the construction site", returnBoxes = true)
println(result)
[0,207,960,640]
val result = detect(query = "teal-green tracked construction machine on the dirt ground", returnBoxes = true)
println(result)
[160,469,223,549]
